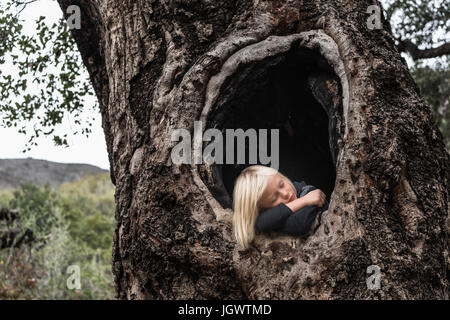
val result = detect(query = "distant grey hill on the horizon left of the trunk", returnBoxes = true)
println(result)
[0,158,108,189]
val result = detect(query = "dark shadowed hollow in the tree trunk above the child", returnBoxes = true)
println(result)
[201,41,343,208]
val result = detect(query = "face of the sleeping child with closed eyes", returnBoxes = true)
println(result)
[258,174,297,210]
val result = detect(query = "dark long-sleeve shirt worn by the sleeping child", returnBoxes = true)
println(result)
[255,181,328,236]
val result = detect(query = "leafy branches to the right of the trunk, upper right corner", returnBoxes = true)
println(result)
[382,0,450,152]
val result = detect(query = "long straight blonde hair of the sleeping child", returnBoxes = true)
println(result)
[233,165,295,249]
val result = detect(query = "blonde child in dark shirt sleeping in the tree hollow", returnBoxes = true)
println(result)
[233,165,328,248]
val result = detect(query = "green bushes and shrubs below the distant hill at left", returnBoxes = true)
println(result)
[0,174,115,299]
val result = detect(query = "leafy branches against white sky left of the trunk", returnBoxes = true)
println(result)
[0,0,96,151]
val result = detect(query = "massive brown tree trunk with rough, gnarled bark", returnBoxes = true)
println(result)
[59,0,449,299]
